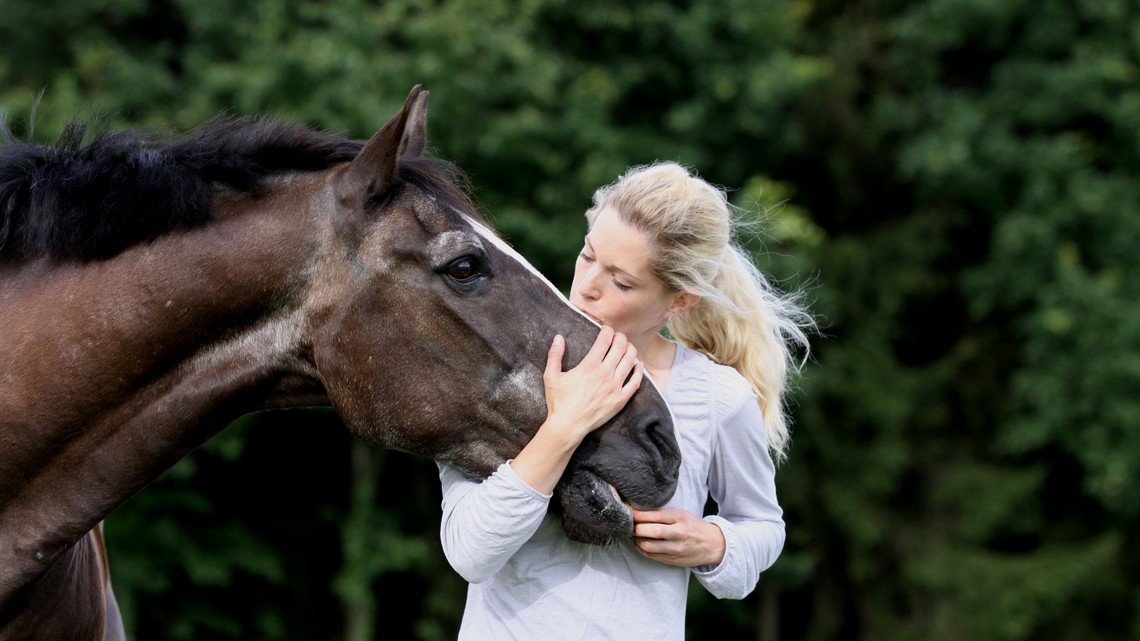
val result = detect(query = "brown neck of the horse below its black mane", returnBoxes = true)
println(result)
[0,175,330,603]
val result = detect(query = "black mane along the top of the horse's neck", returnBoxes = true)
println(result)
[0,116,361,260]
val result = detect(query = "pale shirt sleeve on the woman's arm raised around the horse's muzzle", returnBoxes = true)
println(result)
[437,461,551,583]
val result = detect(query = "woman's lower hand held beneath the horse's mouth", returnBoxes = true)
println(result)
[633,509,725,568]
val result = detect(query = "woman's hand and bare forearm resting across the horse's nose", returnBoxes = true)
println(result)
[511,327,643,494]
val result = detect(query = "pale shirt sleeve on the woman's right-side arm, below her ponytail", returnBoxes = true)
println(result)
[693,395,784,599]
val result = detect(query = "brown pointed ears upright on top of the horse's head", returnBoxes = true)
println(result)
[337,84,428,202]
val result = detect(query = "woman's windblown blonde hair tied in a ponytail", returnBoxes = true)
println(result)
[586,162,814,463]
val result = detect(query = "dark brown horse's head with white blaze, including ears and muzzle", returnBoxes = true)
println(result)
[312,87,681,543]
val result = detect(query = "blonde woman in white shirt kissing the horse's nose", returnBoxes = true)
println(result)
[440,163,809,641]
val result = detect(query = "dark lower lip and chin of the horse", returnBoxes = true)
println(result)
[555,469,634,545]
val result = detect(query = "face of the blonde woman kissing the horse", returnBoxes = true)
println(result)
[570,206,677,349]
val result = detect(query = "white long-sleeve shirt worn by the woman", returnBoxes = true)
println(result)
[439,344,784,641]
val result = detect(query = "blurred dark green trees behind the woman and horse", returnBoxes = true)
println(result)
[0,0,1140,641]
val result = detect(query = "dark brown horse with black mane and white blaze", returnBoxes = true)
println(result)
[0,86,681,641]
